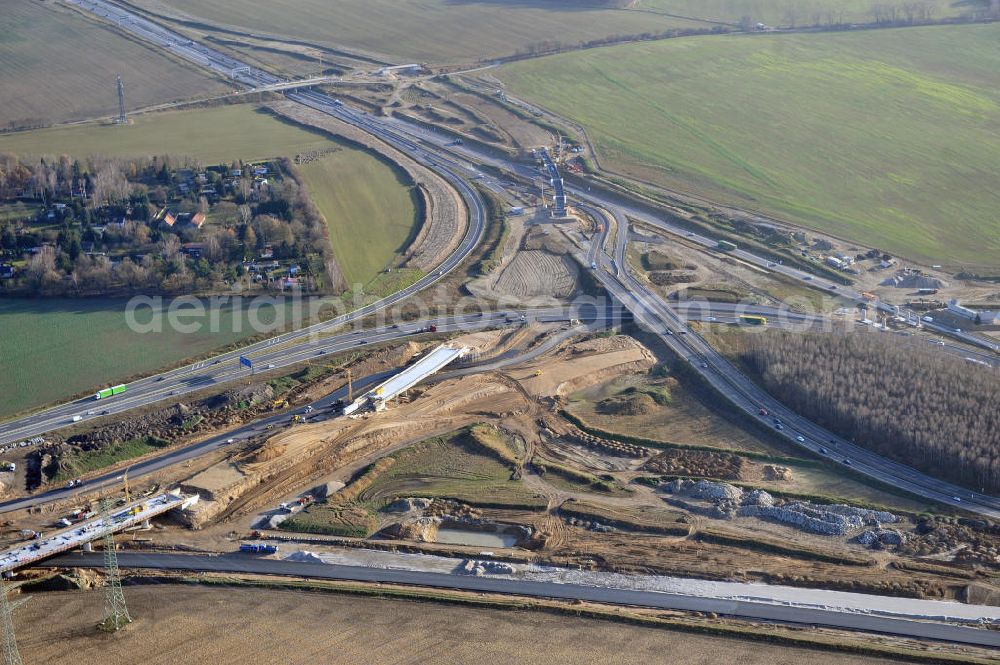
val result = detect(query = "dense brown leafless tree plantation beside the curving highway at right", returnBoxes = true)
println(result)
[739,331,1000,492]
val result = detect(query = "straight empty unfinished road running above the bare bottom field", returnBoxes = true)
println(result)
[43,552,1000,648]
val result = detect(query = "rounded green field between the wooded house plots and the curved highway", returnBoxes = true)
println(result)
[300,150,419,284]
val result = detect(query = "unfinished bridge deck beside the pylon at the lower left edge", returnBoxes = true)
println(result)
[0,490,198,573]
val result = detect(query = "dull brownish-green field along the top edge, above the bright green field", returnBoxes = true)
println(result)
[135,0,711,63]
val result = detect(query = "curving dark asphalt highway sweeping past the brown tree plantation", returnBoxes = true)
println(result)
[594,205,1000,519]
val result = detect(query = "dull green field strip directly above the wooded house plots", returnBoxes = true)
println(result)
[0,104,337,164]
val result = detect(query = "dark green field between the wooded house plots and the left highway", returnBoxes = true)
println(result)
[0,299,290,417]
